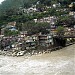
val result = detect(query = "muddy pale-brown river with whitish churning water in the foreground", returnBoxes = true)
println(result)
[0,44,75,75]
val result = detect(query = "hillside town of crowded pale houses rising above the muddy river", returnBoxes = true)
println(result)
[0,1,75,56]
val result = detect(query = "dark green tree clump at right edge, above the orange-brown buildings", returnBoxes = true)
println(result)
[56,15,75,27]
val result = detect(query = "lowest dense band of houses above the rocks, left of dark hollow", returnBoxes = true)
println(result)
[0,30,53,50]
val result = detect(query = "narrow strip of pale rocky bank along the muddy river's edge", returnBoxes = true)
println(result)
[0,43,74,57]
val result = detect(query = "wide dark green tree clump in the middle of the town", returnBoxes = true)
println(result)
[17,21,50,35]
